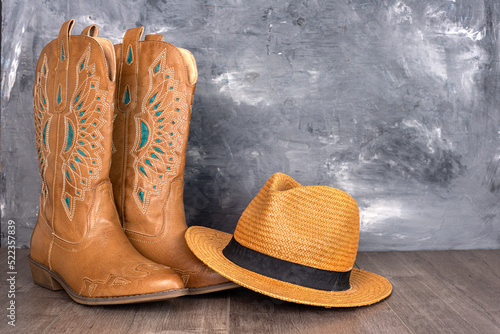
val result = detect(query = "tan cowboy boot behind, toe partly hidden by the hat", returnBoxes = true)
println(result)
[110,27,238,294]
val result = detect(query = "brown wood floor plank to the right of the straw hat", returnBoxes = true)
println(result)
[357,251,500,333]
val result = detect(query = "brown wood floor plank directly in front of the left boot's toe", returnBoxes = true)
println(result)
[46,286,228,334]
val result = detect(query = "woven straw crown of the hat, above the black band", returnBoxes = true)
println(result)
[234,173,359,272]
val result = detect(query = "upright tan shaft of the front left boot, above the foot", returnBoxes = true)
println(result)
[33,20,116,242]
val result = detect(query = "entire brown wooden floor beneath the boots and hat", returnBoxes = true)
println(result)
[0,248,500,334]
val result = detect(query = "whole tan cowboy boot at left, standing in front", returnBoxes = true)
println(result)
[29,20,186,305]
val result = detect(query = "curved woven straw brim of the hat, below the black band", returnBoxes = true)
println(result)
[186,226,392,307]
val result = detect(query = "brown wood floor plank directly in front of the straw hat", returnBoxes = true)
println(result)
[229,289,410,334]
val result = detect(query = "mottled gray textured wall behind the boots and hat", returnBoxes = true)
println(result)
[1,0,500,250]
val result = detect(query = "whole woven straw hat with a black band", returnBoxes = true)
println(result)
[186,173,392,307]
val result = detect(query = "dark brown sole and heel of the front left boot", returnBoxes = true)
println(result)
[28,256,188,305]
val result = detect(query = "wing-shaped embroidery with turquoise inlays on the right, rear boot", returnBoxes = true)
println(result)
[131,50,189,213]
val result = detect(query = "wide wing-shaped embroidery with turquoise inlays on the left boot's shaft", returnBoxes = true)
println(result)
[61,44,109,220]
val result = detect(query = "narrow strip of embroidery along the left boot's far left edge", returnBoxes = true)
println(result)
[33,54,52,206]
